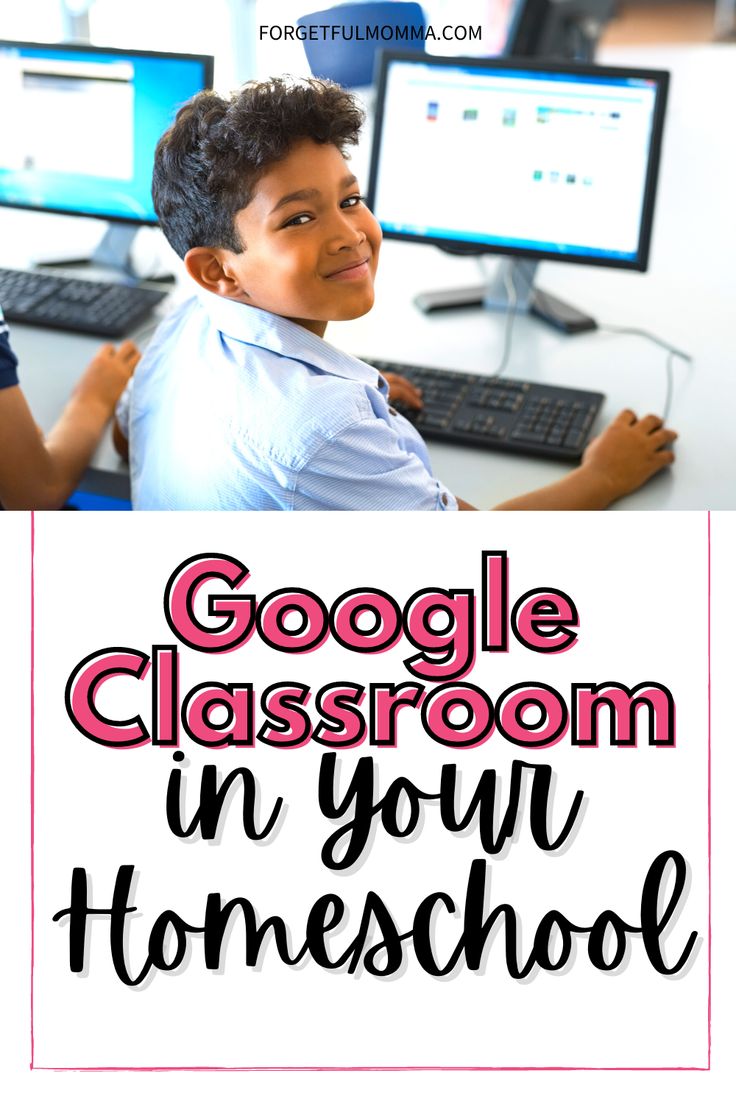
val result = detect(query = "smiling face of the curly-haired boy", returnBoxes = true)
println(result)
[227,139,382,337]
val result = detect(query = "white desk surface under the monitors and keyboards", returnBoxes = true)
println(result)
[0,45,736,509]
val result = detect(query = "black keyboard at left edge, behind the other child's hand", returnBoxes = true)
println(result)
[0,268,167,338]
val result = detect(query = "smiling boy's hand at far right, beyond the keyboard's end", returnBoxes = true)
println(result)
[580,410,678,502]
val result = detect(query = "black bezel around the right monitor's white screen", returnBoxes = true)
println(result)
[366,50,670,272]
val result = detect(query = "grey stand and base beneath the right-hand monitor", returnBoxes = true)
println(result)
[414,257,597,333]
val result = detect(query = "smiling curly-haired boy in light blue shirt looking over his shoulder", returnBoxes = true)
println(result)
[118,79,675,510]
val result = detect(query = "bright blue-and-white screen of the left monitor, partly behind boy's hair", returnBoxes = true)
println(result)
[0,41,213,224]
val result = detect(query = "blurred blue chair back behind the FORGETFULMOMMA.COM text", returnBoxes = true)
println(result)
[297,2,427,88]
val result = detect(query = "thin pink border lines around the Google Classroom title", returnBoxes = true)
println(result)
[30,510,712,1073]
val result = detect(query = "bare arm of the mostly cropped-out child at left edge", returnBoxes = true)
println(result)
[0,341,140,510]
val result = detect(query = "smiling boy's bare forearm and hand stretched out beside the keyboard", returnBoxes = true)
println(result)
[458,410,678,510]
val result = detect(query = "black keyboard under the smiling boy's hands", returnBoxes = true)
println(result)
[363,358,605,460]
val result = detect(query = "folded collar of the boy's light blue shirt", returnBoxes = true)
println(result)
[198,289,386,391]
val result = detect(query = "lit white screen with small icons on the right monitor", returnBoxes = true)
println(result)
[369,53,668,270]
